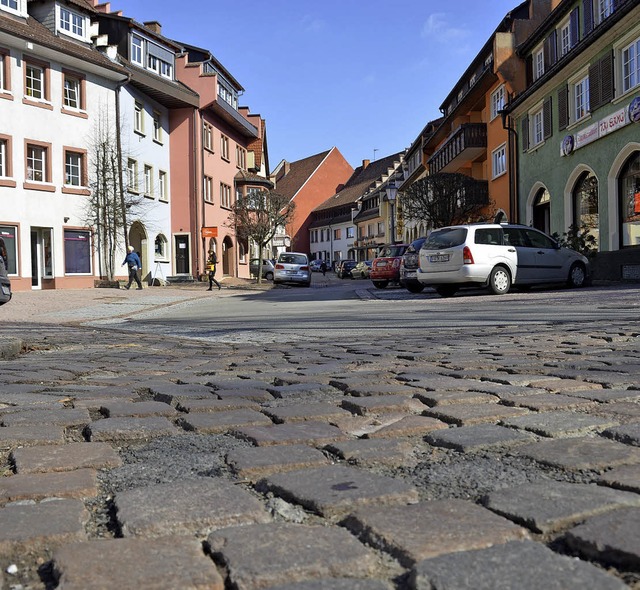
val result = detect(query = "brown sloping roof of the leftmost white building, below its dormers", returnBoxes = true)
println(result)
[0,14,126,78]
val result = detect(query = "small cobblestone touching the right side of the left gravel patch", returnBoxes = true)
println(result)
[226,445,329,481]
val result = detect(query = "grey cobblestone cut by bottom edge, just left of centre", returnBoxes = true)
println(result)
[207,523,379,590]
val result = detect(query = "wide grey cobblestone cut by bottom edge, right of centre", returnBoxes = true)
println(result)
[410,541,628,590]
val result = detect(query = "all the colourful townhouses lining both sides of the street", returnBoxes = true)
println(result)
[0,0,640,290]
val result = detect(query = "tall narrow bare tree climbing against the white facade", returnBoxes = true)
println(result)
[84,109,143,281]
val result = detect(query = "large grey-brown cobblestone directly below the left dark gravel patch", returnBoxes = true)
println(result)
[114,478,270,537]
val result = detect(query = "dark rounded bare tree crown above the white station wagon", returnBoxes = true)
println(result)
[401,172,494,227]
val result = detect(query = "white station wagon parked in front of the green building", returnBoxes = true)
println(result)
[417,223,591,297]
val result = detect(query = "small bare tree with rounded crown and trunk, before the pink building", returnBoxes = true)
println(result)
[227,190,295,283]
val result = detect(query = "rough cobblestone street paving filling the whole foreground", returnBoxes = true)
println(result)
[0,290,640,590]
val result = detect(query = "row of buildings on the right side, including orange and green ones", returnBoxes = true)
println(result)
[310,0,640,279]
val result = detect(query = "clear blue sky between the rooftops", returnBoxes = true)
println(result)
[124,0,520,169]
